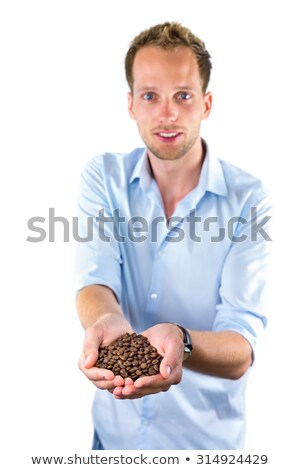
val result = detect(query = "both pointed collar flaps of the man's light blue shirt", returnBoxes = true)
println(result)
[129,143,228,196]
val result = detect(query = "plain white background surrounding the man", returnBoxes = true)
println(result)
[0,0,300,469]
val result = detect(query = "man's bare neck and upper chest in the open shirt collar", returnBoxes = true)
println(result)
[148,139,205,218]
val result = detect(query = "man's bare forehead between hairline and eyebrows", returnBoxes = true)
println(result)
[133,46,201,88]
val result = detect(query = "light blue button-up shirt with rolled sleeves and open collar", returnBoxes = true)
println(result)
[75,141,272,449]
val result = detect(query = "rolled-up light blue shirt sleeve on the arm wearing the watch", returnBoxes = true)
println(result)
[213,186,272,354]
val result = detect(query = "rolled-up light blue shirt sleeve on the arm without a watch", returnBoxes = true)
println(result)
[74,157,122,302]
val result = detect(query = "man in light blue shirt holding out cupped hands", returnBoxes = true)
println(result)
[77,23,270,449]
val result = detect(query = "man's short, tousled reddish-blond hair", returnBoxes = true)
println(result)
[125,22,212,93]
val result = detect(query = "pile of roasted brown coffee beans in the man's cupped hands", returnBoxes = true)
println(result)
[96,333,162,380]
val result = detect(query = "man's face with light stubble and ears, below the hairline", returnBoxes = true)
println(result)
[128,46,211,160]
